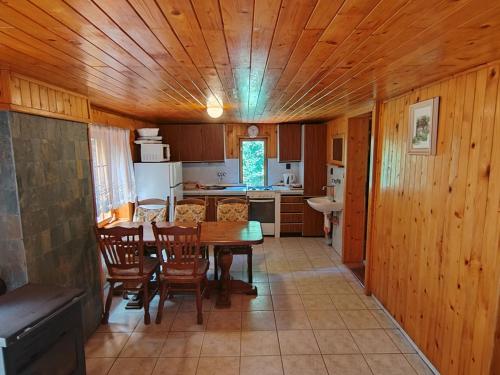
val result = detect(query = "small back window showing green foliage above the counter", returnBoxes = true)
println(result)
[240,139,267,186]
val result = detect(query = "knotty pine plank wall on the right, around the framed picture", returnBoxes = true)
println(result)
[369,65,500,375]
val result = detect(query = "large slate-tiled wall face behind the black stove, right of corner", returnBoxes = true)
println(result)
[0,112,102,335]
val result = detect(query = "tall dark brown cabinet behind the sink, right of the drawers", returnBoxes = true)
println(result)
[302,124,327,236]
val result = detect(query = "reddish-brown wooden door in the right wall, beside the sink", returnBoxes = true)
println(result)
[342,113,372,285]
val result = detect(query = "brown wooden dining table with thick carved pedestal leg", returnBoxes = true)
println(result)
[107,221,264,308]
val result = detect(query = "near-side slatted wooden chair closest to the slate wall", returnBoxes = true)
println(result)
[95,225,160,324]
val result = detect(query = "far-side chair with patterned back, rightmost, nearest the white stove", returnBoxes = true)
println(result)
[214,198,253,283]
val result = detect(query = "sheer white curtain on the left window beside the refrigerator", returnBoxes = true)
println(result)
[89,124,136,221]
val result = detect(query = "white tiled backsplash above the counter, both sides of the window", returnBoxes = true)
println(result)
[182,158,302,185]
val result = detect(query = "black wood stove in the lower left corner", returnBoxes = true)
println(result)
[0,284,85,375]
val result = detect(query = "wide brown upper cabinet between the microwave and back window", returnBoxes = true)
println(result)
[160,124,224,162]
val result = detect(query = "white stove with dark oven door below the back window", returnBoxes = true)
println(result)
[247,186,281,237]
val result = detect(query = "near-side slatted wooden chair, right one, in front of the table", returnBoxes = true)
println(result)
[152,223,210,324]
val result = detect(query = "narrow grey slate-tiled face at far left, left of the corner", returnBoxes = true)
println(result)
[0,111,28,290]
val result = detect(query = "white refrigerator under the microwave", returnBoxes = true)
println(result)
[134,162,183,218]
